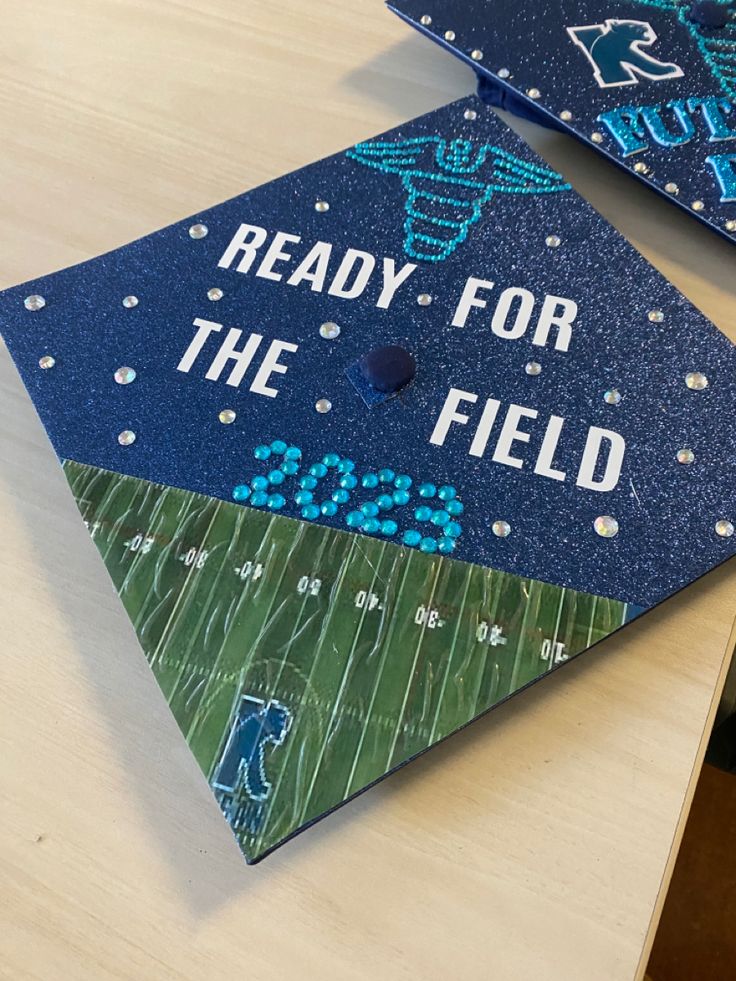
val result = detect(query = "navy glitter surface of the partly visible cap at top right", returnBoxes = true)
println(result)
[388,0,736,242]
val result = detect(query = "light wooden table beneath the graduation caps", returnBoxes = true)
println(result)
[0,0,736,981]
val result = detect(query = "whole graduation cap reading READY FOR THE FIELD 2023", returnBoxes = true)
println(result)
[0,98,736,861]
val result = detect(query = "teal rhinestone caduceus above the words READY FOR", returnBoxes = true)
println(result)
[347,136,570,262]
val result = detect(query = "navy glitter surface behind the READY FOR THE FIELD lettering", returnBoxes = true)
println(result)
[0,98,736,607]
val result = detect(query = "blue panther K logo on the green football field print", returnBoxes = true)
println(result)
[212,695,291,833]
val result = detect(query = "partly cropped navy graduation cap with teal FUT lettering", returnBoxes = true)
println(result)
[389,0,736,241]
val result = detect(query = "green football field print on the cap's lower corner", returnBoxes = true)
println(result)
[64,461,626,861]
